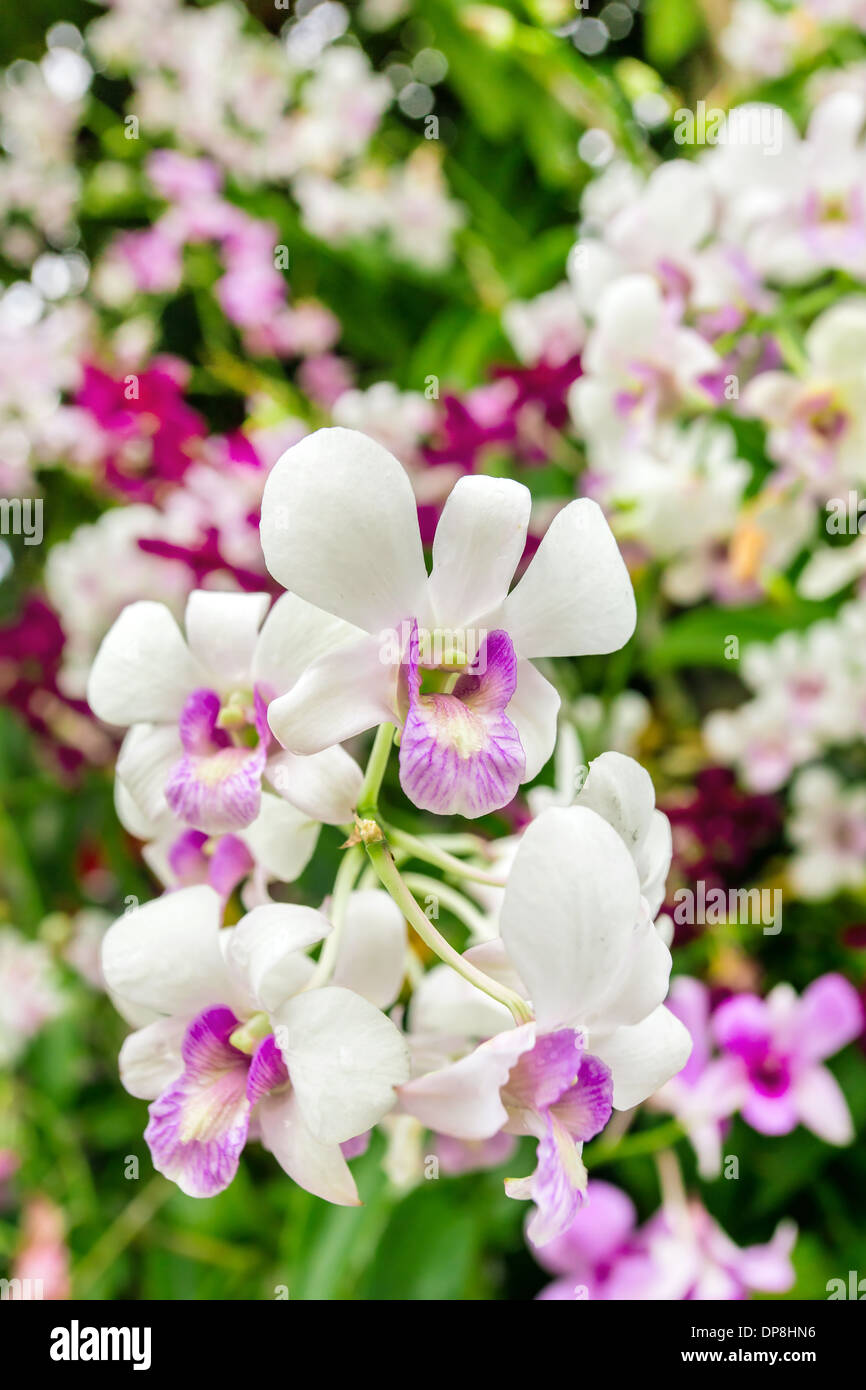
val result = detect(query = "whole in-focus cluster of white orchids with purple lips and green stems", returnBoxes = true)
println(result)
[88,428,689,1241]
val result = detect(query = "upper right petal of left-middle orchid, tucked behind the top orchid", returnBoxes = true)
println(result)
[253,594,364,706]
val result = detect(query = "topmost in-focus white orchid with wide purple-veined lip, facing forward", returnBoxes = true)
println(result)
[261,417,635,817]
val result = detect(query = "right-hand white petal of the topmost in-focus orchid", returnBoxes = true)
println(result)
[505,498,635,656]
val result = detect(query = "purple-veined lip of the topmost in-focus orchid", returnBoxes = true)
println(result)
[400,623,525,819]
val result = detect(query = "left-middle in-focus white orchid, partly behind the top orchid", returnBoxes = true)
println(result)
[88,589,361,891]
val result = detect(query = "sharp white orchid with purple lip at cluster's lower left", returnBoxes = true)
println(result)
[103,885,409,1205]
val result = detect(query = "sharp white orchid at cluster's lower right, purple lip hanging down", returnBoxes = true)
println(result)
[399,811,691,1244]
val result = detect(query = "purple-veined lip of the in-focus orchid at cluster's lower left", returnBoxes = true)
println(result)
[145,1006,252,1197]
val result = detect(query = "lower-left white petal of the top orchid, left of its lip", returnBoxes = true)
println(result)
[268,637,398,755]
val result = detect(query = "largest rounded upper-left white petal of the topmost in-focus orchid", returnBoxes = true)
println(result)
[261,428,427,632]
